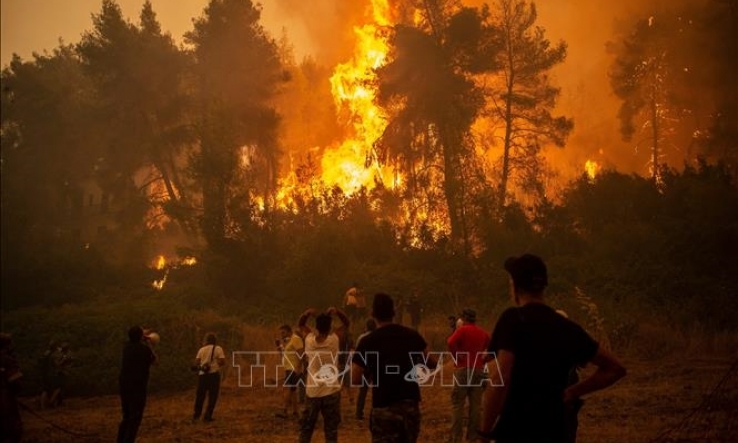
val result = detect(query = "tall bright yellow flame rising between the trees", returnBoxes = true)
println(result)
[321,0,393,194]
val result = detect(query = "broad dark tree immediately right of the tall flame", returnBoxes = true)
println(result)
[376,1,496,252]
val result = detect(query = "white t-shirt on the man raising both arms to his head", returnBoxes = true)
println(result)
[305,332,342,398]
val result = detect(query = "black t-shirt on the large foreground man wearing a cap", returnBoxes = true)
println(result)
[489,303,599,443]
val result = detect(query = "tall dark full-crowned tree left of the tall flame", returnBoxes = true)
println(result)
[185,0,284,247]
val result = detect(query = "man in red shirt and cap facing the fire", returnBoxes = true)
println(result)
[446,308,489,443]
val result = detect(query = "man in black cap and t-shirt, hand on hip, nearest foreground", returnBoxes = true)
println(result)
[477,254,626,443]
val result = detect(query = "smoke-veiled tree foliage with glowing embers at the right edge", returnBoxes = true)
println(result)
[609,0,738,181]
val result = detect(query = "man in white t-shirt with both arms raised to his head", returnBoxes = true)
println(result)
[298,308,349,443]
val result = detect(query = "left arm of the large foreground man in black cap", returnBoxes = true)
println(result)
[477,349,515,443]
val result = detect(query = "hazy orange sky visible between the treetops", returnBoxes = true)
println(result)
[0,0,646,177]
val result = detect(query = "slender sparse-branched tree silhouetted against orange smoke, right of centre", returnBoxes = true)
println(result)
[487,0,574,205]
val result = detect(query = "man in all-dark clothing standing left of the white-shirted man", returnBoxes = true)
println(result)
[118,326,156,443]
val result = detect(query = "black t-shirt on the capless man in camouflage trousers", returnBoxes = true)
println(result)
[352,324,427,408]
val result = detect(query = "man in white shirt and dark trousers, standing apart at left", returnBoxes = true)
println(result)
[192,332,225,422]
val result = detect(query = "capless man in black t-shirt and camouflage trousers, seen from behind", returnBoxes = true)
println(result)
[351,293,436,443]
